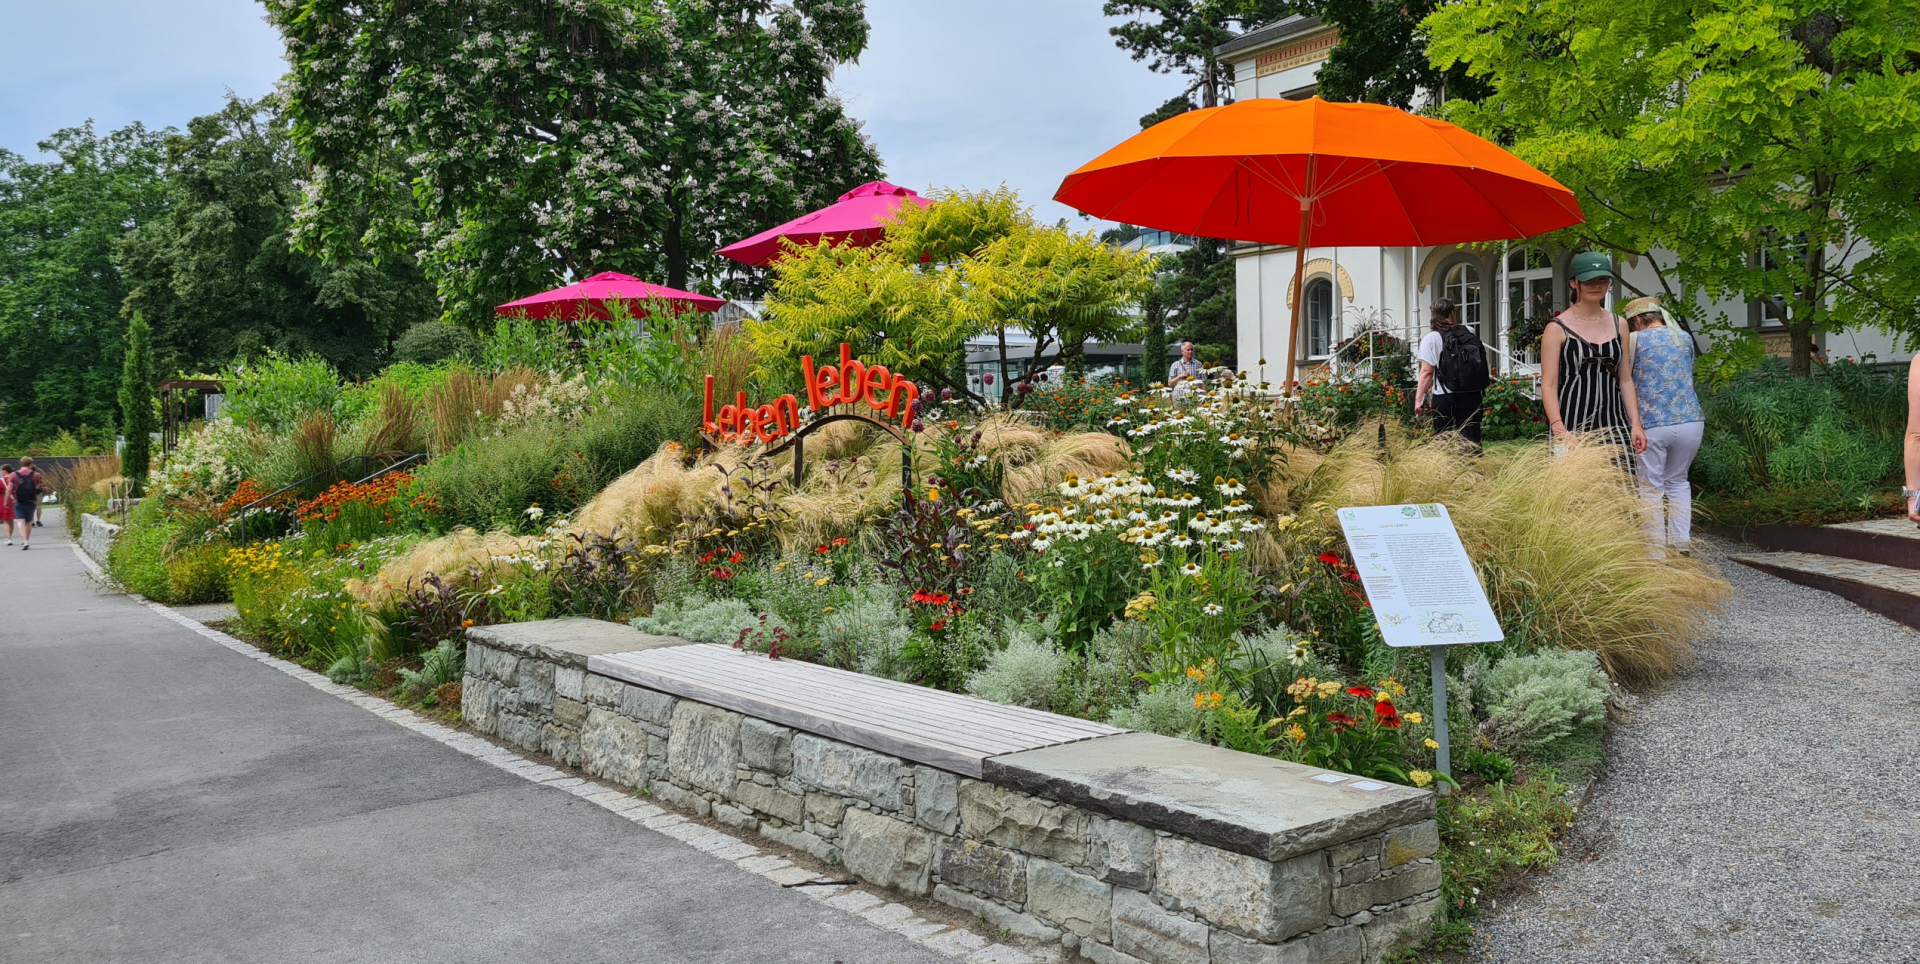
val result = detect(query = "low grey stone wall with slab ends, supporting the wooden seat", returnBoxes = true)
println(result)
[463,620,1440,964]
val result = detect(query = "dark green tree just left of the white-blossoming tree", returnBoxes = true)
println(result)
[117,98,438,376]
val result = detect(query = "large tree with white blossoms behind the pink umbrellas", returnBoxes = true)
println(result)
[265,0,879,321]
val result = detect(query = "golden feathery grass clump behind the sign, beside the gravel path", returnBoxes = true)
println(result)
[1294,428,1730,686]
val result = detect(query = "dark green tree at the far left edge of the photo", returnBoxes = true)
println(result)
[0,123,167,446]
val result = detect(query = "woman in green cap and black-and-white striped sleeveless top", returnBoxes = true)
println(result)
[1540,252,1647,469]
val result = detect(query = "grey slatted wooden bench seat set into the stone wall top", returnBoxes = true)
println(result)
[588,643,1127,778]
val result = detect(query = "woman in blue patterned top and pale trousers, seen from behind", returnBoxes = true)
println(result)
[1620,298,1707,555]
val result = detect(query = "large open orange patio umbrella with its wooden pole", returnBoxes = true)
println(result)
[1054,98,1584,390]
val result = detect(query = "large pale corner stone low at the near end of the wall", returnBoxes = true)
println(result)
[1154,837,1332,941]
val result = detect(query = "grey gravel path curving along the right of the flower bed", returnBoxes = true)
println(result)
[1473,533,1920,964]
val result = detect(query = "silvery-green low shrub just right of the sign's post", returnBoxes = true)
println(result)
[1475,649,1607,755]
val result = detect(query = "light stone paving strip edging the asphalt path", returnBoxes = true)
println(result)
[60,543,1052,964]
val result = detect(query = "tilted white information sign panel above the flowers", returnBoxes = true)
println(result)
[1338,503,1505,647]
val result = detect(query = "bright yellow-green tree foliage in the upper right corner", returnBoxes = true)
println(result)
[1425,0,1920,374]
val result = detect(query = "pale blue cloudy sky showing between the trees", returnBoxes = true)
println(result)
[0,0,1181,223]
